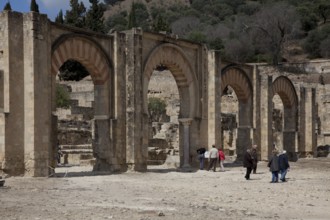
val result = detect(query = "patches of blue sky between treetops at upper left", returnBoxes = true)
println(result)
[0,0,96,21]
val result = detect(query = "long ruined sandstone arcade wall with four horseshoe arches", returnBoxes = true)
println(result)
[0,11,330,176]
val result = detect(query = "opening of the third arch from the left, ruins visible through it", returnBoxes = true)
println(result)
[221,86,239,161]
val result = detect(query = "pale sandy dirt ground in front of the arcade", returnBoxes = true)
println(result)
[0,158,330,220]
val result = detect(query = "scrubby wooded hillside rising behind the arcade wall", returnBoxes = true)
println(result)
[104,0,330,65]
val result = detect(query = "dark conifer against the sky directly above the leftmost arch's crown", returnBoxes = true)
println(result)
[64,0,86,28]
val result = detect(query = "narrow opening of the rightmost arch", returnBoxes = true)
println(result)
[272,94,284,151]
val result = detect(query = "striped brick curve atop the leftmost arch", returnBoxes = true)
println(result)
[51,37,110,84]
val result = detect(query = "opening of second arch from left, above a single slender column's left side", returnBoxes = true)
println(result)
[147,65,180,170]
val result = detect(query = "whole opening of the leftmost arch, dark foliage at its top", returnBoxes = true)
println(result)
[55,59,95,173]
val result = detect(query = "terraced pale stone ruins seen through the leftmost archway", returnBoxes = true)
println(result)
[56,76,95,165]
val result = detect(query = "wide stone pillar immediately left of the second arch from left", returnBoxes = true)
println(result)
[126,29,148,171]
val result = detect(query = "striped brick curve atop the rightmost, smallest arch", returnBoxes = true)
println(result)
[272,76,298,108]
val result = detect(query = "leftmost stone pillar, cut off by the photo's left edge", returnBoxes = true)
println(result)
[0,11,25,176]
